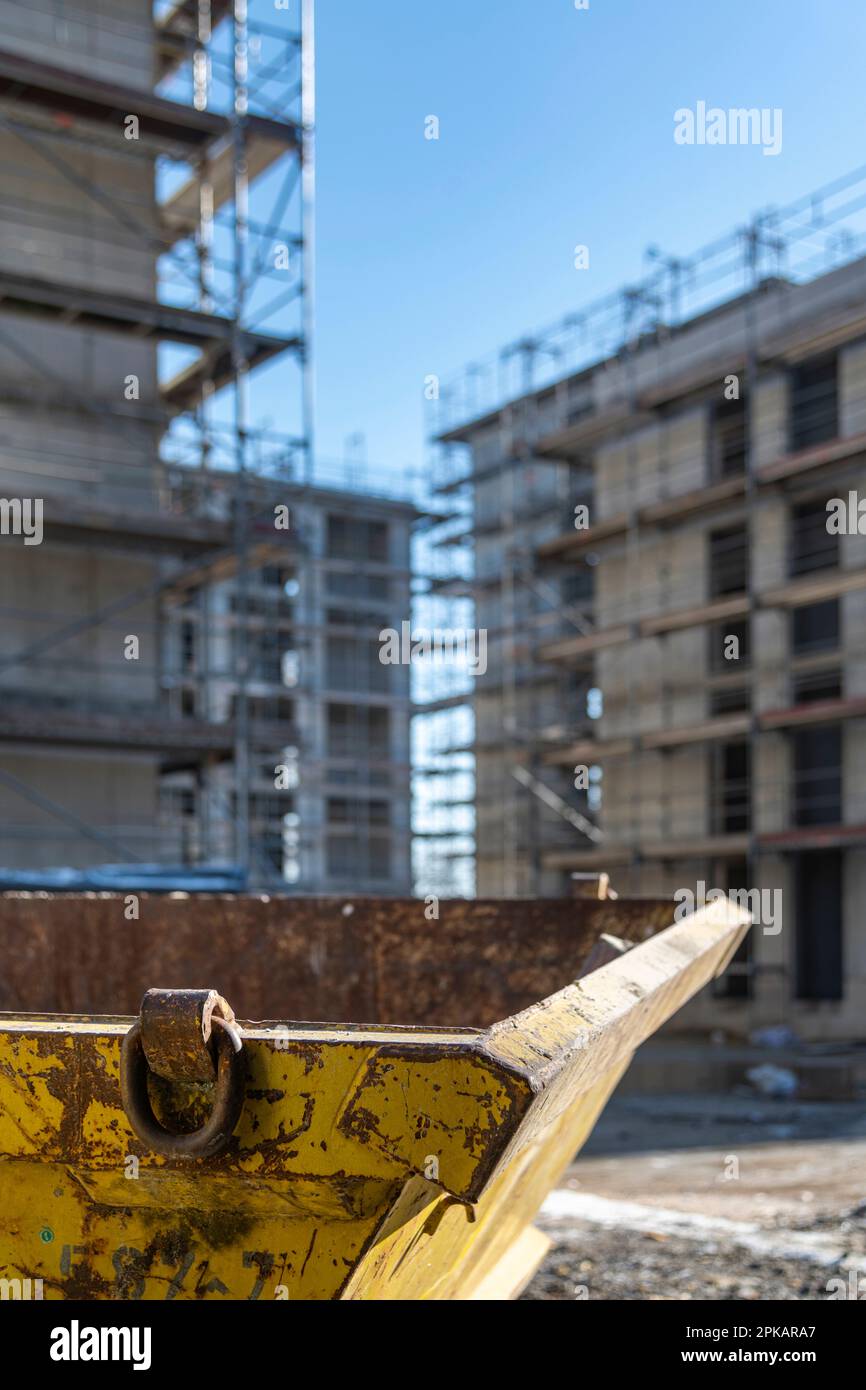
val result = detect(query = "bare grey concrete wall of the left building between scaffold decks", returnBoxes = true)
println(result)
[0,0,164,867]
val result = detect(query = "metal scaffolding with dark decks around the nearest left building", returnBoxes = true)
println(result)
[0,0,314,872]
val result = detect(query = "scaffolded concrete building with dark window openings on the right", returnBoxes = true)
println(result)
[436,172,866,1041]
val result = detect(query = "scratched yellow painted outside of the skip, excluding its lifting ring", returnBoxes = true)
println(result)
[0,904,745,1300]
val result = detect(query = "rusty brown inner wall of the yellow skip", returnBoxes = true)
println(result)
[0,894,673,1027]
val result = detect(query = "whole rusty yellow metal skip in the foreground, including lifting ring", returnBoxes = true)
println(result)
[0,894,748,1300]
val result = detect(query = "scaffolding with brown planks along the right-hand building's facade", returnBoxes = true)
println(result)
[431,170,866,892]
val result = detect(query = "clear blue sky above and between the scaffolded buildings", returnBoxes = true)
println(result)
[258,0,866,489]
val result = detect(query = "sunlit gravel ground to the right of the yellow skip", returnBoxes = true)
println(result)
[523,1094,866,1300]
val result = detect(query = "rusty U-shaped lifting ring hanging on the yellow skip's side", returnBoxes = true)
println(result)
[121,1015,246,1158]
